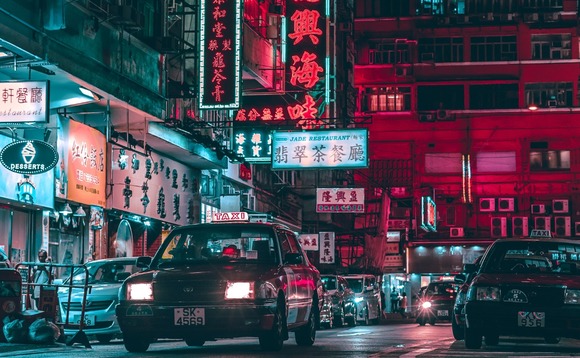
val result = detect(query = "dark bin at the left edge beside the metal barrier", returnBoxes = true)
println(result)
[0,268,22,340]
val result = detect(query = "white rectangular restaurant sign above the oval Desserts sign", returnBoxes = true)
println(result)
[0,81,49,123]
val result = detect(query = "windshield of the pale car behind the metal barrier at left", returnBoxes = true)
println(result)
[64,261,140,285]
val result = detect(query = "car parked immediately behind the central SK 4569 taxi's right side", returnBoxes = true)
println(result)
[320,275,356,328]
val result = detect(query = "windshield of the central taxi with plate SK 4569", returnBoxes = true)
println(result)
[152,224,278,267]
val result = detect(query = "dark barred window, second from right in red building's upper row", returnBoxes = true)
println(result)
[471,36,518,62]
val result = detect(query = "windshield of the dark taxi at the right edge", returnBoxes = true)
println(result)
[482,241,580,275]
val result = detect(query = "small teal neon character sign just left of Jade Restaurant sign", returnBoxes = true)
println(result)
[232,127,272,163]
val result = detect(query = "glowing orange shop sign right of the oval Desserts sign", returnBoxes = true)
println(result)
[55,117,107,207]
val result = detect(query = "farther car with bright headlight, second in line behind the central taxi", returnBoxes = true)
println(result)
[344,274,381,325]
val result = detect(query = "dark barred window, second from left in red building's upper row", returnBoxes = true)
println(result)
[418,37,463,62]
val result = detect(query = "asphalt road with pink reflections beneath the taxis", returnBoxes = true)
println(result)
[0,323,580,358]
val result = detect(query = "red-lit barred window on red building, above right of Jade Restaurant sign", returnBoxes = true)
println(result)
[361,87,411,112]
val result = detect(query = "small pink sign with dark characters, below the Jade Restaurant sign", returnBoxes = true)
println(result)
[316,188,365,213]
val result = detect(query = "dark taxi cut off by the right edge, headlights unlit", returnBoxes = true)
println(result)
[465,238,580,349]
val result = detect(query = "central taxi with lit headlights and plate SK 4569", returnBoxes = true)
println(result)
[116,213,323,352]
